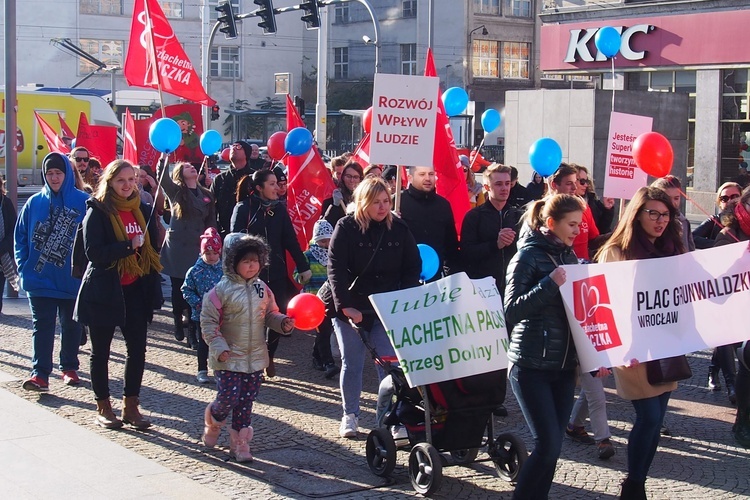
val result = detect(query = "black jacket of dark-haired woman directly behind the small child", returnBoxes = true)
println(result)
[229,195,310,286]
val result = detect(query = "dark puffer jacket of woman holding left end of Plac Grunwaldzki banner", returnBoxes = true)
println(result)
[505,231,578,370]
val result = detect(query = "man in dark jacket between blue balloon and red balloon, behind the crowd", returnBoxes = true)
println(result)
[211,141,258,238]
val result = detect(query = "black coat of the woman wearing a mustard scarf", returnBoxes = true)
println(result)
[73,198,162,327]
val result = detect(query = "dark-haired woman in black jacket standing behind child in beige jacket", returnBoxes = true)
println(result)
[230,169,312,377]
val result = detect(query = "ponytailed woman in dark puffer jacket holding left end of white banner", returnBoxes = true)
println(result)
[505,194,585,499]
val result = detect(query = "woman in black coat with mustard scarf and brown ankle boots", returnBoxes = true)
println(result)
[75,160,161,430]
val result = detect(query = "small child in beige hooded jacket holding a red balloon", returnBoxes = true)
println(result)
[200,233,294,462]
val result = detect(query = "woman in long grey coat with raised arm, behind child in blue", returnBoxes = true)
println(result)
[156,162,216,349]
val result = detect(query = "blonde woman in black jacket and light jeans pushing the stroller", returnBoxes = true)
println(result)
[328,177,422,438]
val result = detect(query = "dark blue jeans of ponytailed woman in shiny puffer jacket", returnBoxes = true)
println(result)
[510,365,576,500]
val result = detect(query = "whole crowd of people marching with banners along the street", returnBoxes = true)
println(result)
[5,141,750,499]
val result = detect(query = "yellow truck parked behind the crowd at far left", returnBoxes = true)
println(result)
[0,88,120,186]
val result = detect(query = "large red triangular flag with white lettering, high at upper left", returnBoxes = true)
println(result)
[123,0,216,106]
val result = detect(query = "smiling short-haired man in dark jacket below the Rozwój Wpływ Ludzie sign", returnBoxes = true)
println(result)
[400,167,459,281]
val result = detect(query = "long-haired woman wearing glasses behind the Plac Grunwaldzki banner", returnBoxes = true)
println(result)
[596,187,685,499]
